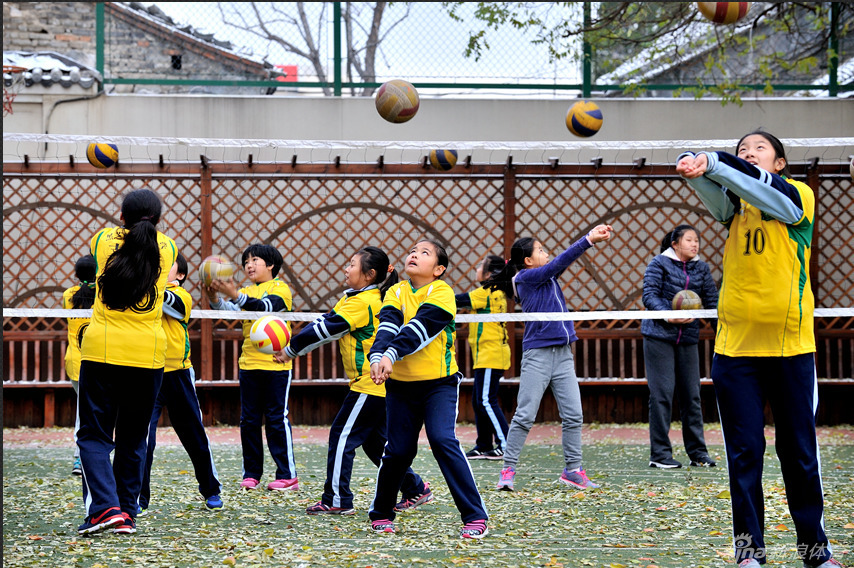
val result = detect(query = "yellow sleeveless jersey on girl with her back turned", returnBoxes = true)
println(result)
[81,227,178,369]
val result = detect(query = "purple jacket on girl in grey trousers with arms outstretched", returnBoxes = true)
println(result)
[513,236,593,350]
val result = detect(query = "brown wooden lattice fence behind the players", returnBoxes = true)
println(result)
[3,160,854,426]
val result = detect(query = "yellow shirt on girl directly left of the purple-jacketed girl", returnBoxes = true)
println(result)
[468,287,510,370]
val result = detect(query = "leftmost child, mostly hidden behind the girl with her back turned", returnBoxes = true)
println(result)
[62,254,95,475]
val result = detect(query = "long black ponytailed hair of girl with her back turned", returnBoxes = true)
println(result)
[98,188,162,312]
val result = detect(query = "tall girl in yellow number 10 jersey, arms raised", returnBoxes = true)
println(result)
[676,130,841,568]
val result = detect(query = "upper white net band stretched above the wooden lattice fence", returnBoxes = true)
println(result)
[3,132,854,164]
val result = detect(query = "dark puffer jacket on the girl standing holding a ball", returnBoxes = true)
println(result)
[641,248,718,345]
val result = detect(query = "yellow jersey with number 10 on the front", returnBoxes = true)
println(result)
[715,180,815,357]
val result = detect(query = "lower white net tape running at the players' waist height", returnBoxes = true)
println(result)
[3,308,854,323]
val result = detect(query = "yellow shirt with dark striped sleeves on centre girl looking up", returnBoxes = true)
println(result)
[378,280,459,381]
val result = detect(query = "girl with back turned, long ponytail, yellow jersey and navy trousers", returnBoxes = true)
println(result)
[75,188,178,534]
